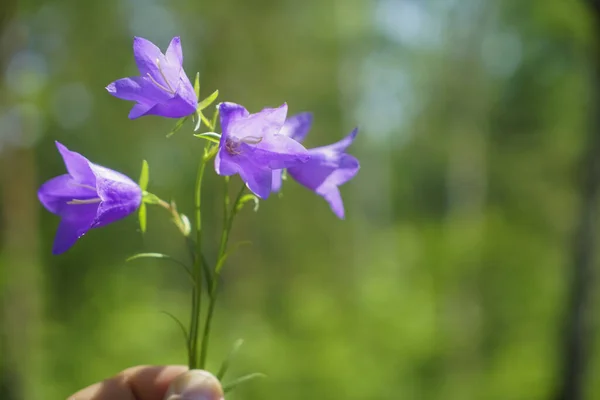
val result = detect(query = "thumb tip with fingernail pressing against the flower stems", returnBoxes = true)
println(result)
[164,369,225,400]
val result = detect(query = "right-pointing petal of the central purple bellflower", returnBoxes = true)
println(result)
[252,135,310,169]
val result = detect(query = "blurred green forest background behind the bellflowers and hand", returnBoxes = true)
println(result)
[0,0,600,400]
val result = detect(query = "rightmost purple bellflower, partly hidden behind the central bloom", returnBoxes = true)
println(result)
[273,113,360,219]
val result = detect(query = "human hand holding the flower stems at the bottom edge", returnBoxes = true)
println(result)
[68,365,224,400]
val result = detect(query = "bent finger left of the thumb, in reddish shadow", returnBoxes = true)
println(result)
[68,365,187,400]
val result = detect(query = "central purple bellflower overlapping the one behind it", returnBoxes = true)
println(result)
[215,103,310,199]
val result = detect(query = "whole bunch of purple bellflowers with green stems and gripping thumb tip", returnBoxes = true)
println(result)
[38,37,359,400]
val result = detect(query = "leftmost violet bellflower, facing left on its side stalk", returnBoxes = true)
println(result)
[38,142,142,254]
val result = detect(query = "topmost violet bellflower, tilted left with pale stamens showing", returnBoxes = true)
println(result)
[106,36,198,119]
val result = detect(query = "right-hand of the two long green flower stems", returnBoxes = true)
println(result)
[200,182,245,369]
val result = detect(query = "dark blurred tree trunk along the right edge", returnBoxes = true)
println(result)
[556,0,600,400]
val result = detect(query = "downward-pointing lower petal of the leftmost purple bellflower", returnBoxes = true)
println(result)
[52,204,98,255]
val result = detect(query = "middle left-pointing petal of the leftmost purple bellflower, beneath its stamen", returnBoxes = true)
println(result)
[38,174,98,216]
